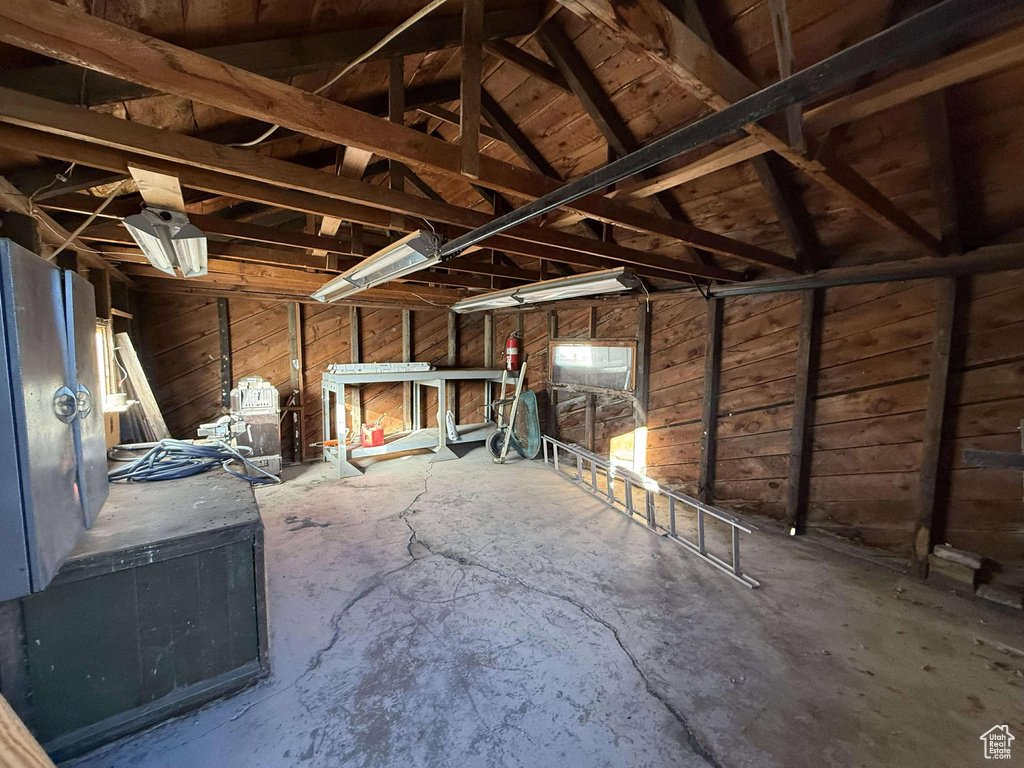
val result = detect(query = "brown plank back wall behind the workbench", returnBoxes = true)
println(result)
[139,294,487,456]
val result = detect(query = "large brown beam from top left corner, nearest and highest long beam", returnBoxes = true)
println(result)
[0,0,785,268]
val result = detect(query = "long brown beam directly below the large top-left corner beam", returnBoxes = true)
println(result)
[0,108,745,281]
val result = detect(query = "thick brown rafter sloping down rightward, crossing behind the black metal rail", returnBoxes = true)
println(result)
[559,0,941,253]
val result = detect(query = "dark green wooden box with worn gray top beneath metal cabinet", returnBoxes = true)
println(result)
[0,472,269,761]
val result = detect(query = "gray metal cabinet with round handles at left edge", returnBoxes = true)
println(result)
[0,239,106,600]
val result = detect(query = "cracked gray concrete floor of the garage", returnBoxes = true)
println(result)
[70,449,1024,768]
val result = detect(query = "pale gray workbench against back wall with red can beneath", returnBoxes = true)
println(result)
[321,368,516,477]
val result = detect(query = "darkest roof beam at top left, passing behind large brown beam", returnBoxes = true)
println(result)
[0,8,540,106]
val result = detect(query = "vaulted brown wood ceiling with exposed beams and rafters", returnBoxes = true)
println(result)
[0,0,1024,304]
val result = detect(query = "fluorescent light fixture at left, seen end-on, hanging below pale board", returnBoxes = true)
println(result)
[124,207,206,278]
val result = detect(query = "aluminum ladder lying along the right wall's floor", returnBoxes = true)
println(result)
[542,435,761,589]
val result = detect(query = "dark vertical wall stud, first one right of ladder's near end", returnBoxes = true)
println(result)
[785,290,821,536]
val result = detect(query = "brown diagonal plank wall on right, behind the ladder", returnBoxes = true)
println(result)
[527,272,1024,567]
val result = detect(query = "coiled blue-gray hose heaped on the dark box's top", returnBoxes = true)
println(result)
[106,438,281,483]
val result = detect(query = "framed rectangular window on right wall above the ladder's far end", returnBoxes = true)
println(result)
[549,341,636,391]
